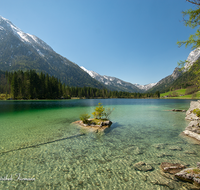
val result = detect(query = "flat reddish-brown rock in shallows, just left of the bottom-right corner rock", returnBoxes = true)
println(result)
[160,162,186,174]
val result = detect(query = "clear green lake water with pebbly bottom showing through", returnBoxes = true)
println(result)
[0,99,200,190]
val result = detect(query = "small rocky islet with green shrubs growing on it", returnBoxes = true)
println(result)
[74,103,114,132]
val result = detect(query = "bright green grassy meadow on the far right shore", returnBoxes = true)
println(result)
[160,89,200,99]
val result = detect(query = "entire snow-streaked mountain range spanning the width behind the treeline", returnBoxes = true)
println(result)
[0,16,200,92]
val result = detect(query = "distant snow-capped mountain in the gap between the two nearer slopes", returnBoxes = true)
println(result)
[81,66,156,92]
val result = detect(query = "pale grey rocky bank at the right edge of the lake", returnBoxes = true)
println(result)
[183,100,200,141]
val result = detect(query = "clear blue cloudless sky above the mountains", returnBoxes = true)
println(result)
[0,0,195,84]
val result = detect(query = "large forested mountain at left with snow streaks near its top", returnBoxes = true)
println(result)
[0,16,105,88]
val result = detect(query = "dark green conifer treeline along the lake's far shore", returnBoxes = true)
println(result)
[0,70,160,99]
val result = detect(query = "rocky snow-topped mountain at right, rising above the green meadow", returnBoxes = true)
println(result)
[148,48,200,92]
